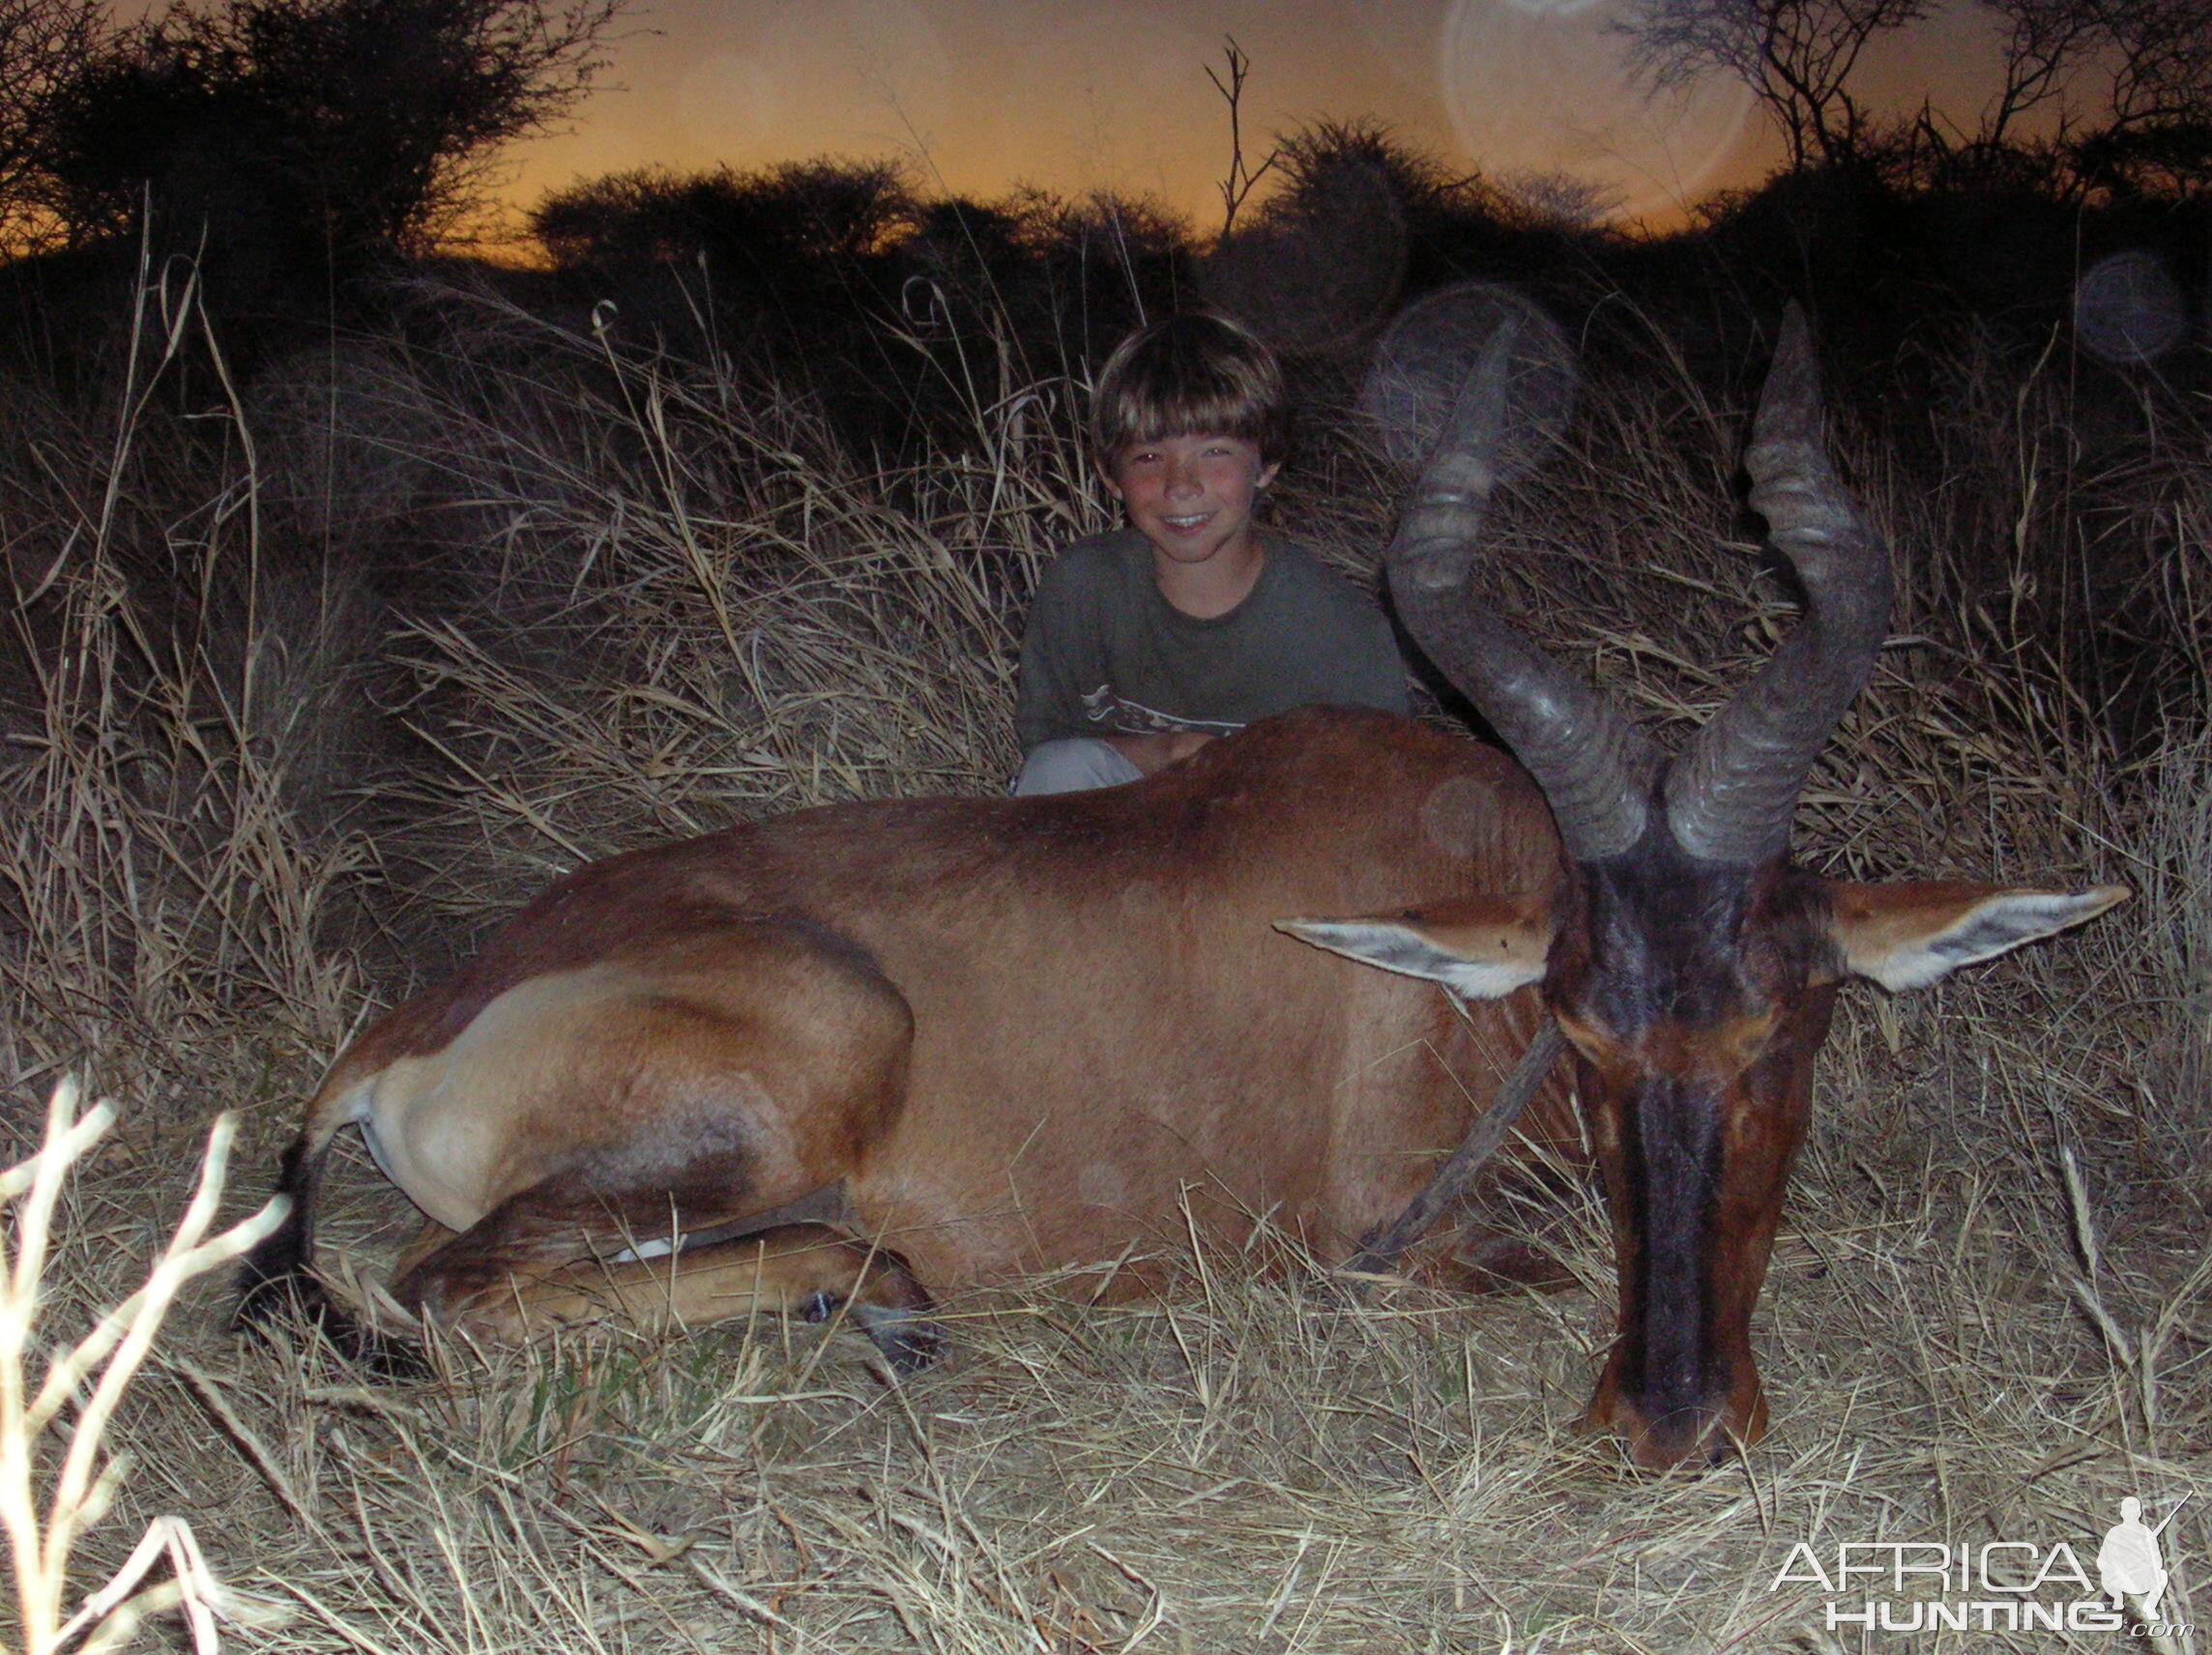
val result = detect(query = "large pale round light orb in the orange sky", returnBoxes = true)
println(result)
[1438,0,1752,217]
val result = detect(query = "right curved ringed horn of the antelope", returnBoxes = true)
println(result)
[1666,304,1889,863]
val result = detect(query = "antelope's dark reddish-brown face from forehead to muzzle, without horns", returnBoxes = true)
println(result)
[1544,823,1836,1469]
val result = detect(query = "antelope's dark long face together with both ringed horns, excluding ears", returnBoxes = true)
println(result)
[1389,309,1889,1469]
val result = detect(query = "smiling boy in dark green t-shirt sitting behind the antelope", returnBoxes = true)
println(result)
[1013,314,1407,795]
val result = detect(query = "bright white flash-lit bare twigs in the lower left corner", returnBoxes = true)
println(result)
[0,1078,285,1655]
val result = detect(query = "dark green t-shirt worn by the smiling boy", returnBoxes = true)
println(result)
[1013,529,1407,752]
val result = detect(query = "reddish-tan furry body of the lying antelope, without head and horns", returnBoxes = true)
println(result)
[280,711,1575,1336]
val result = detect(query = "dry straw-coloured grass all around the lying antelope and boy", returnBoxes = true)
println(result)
[0,277,2212,1655]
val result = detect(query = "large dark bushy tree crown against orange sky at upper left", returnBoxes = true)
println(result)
[40,0,624,263]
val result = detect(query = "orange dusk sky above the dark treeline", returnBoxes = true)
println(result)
[462,0,2025,225]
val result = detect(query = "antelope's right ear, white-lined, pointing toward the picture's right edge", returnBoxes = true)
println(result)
[1829,883,2133,994]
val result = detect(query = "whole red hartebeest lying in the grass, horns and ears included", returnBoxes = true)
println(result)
[246,314,2126,1466]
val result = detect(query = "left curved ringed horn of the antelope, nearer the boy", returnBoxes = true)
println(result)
[1387,323,1659,860]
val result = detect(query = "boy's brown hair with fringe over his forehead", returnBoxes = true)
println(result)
[1091,309,1290,467]
